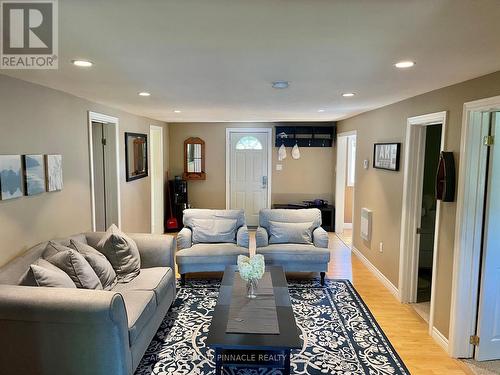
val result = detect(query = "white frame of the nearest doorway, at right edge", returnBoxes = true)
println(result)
[449,96,500,358]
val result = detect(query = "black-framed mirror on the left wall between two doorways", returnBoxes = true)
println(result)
[125,133,148,182]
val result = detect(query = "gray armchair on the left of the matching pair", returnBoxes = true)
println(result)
[176,209,249,282]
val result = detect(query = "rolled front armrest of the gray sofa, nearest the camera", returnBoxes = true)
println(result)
[0,285,132,375]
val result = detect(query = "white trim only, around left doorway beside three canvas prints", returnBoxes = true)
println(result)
[87,111,122,232]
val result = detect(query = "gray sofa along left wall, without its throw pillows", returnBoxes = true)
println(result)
[0,233,175,375]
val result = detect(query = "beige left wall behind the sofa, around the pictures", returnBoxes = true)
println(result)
[0,75,168,265]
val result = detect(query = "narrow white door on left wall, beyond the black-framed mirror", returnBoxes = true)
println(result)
[149,125,164,234]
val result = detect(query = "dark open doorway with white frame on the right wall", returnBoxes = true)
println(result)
[399,112,446,343]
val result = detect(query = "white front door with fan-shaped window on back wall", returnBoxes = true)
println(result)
[229,131,270,226]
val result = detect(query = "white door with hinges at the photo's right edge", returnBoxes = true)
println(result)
[475,112,500,361]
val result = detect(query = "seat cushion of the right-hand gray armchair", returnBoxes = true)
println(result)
[257,244,330,264]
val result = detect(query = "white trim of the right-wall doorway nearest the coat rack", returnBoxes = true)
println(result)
[335,130,358,233]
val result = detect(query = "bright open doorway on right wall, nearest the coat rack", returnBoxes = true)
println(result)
[335,131,357,246]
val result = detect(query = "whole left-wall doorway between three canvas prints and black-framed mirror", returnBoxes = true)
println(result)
[89,112,121,231]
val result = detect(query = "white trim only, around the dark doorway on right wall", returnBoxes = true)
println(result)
[398,111,448,336]
